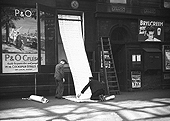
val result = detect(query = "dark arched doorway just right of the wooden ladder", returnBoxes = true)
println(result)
[110,26,131,91]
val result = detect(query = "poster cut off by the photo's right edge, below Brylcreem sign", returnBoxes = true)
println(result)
[164,46,170,70]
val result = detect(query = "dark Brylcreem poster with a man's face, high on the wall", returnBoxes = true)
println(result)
[138,19,164,42]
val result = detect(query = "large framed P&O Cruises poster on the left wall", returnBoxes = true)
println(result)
[1,7,45,73]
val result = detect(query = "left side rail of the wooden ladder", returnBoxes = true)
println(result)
[101,37,110,95]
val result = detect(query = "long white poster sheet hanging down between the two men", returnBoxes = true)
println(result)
[59,20,92,99]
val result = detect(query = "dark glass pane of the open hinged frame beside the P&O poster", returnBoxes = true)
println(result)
[40,11,55,65]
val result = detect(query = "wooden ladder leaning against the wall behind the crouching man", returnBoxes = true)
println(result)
[101,37,120,95]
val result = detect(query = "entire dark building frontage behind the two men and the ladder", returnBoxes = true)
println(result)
[0,0,170,97]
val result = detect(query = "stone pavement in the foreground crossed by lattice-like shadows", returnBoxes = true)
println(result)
[0,89,170,121]
